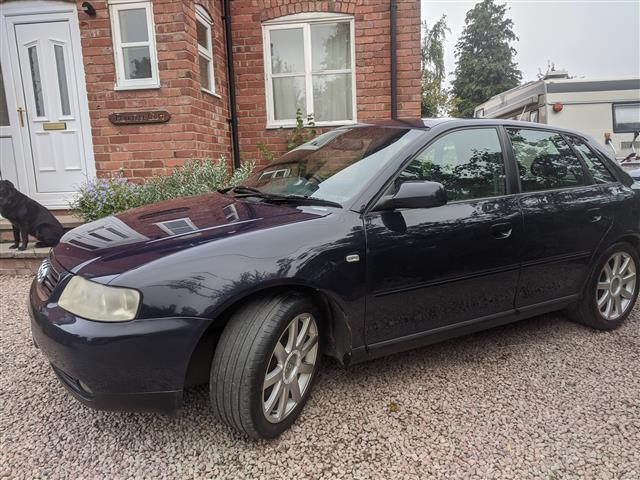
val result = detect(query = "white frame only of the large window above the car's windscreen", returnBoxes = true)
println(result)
[262,12,358,128]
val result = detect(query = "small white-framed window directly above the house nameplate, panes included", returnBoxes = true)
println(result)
[109,0,160,90]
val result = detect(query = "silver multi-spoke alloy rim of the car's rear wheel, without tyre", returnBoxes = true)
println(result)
[596,252,636,320]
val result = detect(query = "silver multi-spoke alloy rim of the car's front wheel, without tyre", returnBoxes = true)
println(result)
[262,313,318,423]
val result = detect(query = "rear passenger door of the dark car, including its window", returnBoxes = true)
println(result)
[506,127,612,308]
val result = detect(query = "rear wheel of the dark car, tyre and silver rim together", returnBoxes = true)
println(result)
[569,242,640,330]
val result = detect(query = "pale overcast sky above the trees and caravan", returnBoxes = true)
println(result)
[421,0,640,86]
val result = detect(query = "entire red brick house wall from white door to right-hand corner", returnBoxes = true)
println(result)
[76,0,420,176]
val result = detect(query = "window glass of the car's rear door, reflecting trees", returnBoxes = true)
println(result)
[507,128,586,192]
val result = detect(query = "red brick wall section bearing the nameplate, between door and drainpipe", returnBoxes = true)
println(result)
[76,0,230,179]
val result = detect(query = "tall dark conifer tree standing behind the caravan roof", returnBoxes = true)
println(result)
[451,0,522,117]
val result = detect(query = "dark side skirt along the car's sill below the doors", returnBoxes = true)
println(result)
[345,295,580,365]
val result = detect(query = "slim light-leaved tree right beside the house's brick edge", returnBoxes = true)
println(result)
[421,15,451,117]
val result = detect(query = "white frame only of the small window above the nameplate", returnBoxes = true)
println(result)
[109,0,160,90]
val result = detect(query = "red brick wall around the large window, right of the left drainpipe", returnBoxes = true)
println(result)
[231,0,420,160]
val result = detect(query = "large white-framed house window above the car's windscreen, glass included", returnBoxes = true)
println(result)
[263,13,356,127]
